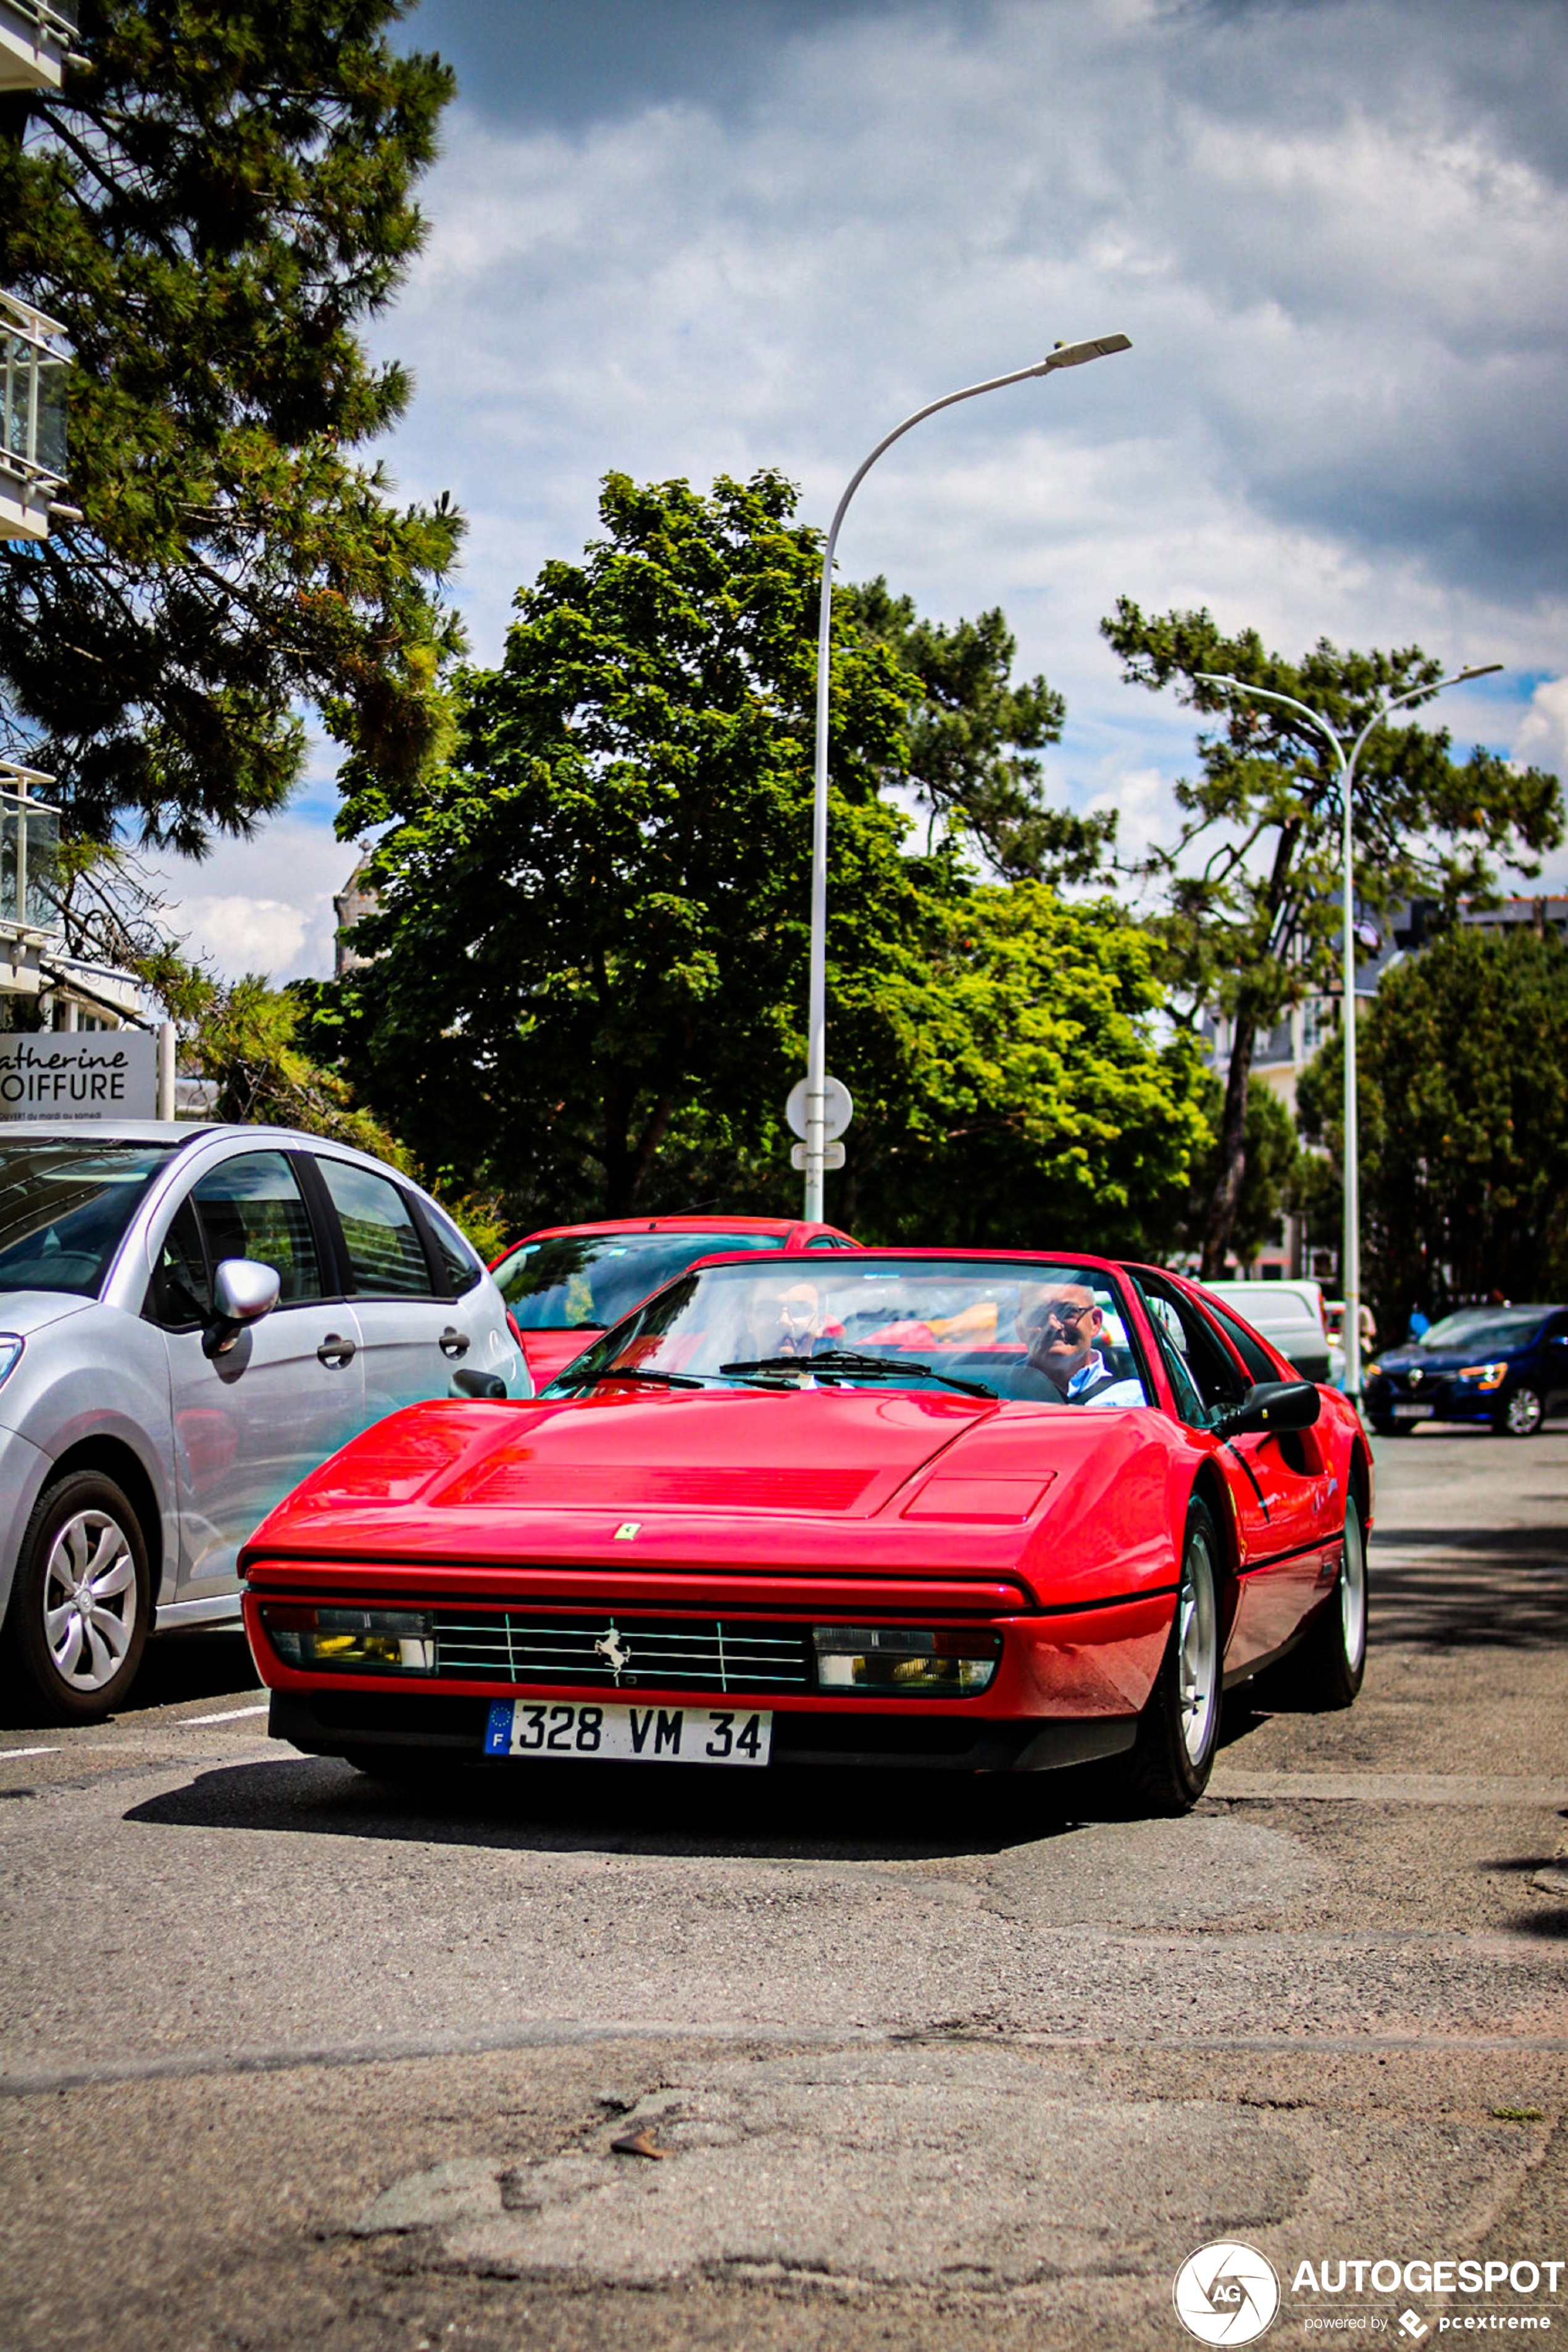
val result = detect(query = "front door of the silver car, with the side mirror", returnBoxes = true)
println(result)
[148,1150,364,1599]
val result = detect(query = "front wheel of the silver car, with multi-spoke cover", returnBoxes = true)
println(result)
[0,1470,153,1724]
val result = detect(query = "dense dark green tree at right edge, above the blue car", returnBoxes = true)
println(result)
[1298,927,1568,1333]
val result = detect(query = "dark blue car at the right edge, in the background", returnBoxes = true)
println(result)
[1366,1306,1568,1437]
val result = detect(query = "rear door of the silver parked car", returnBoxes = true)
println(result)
[312,1153,475,1423]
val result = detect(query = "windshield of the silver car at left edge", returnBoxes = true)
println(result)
[0,1138,178,1298]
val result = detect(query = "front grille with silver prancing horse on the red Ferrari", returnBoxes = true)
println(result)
[435,1609,814,1691]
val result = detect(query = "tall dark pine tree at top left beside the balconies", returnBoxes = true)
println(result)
[0,0,459,851]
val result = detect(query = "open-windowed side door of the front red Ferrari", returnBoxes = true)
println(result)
[1140,1277,1330,1667]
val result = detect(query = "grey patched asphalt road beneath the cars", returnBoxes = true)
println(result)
[0,1432,1568,2352]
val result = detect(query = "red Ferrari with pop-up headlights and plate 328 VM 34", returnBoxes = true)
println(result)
[242,1249,1373,1811]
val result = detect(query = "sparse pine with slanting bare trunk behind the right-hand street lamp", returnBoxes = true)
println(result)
[1100,598,1563,1277]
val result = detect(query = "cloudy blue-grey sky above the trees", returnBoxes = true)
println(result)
[150,0,1568,976]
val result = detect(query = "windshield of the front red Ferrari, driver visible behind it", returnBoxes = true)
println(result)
[545,1258,1149,1406]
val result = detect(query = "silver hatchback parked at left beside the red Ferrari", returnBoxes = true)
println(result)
[0,1122,532,1722]
